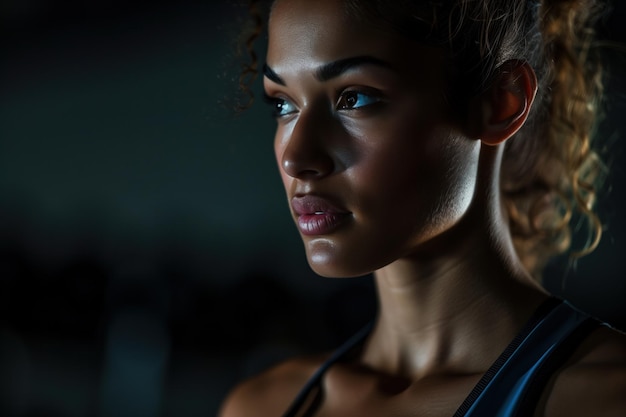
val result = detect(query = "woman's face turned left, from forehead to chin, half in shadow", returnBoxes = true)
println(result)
[264,0,480,277]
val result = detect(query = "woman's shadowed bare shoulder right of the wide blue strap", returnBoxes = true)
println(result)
[540,327,626,417]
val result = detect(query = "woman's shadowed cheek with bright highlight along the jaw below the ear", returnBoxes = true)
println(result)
[352,130,480,239]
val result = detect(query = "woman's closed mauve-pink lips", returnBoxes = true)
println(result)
[291,195,351,236]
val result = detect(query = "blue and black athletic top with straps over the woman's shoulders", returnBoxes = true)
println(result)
[283,297,602,417]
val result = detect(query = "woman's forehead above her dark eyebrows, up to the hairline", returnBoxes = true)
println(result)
[267,0,442,72]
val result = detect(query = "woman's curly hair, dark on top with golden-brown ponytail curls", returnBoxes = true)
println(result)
[241,0,604,279]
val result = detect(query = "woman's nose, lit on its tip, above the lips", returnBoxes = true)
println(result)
[278,106,336,179]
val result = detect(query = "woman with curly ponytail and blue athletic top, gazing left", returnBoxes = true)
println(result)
[221,0,626,417]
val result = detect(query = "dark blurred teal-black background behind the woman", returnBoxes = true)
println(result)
[0,0,626,417]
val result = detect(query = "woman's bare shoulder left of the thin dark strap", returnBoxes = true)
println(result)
[219,356,325,417]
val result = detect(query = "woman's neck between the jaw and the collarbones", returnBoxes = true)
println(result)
[363,145,547,379]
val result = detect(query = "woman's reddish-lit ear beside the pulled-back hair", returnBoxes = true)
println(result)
[475,60,537,146]
